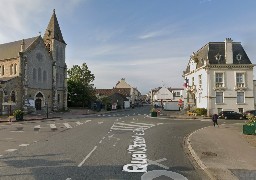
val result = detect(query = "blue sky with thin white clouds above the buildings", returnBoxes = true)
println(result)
[0,0,256,94]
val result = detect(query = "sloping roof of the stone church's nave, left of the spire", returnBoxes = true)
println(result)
[0,36,38,60]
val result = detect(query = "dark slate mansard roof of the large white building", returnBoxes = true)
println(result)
[185,42,252,73]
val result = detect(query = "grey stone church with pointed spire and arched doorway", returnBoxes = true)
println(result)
[0,10,67,114]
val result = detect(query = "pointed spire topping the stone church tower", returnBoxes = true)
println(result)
[43,9,66,44]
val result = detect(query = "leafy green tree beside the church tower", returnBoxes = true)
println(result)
[67,63,95,107]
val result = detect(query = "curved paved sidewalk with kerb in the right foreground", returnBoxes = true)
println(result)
[187,123,256,180]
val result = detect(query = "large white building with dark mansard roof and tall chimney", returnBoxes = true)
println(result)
[183,38,254,115]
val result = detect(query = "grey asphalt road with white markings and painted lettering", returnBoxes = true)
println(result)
[0,107,215,180]
